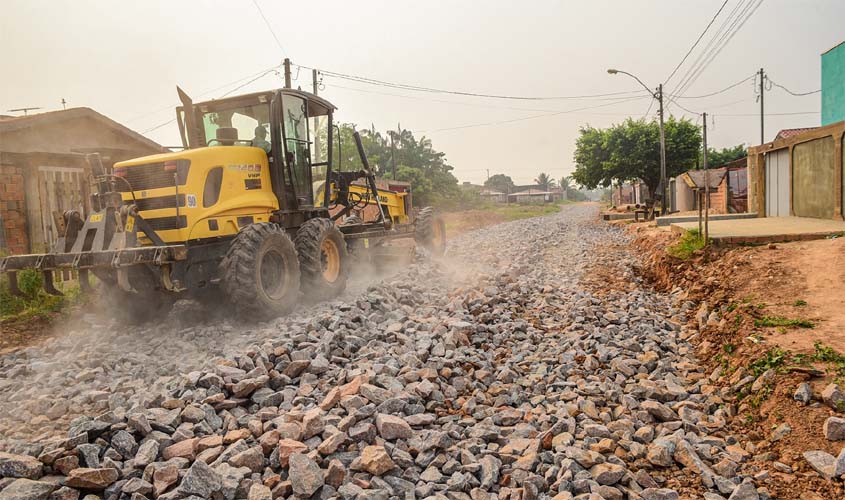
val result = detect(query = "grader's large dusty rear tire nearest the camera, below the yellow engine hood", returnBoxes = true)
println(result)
[220,222,300,319]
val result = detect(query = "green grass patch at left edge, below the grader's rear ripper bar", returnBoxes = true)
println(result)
[0,269,79,322]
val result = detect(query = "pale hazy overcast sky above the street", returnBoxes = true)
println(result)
[0,0,845,183]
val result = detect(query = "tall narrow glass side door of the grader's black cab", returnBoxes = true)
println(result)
[282,94,314,207]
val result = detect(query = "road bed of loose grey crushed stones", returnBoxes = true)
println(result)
[0,205,767,500]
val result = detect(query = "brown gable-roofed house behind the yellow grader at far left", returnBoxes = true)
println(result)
[0,108,164,253]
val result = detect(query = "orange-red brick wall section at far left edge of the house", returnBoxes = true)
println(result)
[0,165,29,254]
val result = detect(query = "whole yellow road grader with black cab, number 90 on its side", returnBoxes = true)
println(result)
[0,88,445,318]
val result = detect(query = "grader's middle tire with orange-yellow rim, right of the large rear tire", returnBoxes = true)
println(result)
[294,218,349,300]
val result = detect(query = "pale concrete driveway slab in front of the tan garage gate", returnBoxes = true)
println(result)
[671,217,845,244]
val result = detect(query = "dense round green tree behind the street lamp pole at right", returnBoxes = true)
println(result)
[572,117,701,198]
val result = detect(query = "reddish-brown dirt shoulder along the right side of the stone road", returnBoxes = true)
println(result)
[628,224,845,499]
